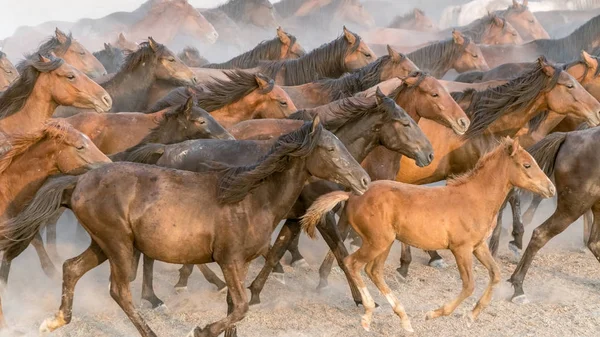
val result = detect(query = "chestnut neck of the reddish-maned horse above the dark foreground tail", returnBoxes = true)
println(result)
[0,142,59,219]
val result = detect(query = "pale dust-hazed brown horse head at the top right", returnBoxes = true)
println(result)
[494,0,550,41]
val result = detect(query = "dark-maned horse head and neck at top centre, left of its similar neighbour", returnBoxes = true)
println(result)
[202,27,306,69]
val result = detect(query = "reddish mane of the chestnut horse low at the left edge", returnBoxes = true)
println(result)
[0,119,77,174]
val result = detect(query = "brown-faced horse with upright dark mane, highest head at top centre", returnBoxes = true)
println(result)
[257,26,377,86]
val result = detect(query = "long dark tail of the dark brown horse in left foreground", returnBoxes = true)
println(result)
[0,175,79,261]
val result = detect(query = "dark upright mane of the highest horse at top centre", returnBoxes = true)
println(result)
[258,33,361,85]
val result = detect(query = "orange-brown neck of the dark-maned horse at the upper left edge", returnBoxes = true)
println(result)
[0,83,58,133]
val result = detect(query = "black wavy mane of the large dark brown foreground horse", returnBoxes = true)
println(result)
[217,122,323,204]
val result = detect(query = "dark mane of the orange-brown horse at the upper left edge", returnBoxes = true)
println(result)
[0,57,65,119]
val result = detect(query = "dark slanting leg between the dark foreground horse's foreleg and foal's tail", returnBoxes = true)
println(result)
[248,219,302,305]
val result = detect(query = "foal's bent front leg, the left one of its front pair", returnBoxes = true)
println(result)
[425,247,475,319]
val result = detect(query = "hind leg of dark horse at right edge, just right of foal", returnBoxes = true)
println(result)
[509,202,589,303]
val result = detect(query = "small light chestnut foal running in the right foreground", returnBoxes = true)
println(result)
[302,137,556,332]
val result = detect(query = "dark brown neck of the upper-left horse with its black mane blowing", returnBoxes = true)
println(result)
[102,65,155,112]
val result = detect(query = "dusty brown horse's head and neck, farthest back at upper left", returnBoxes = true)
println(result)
[17,28,106,78]
